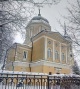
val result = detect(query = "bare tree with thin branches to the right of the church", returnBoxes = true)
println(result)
[58,0,80,59]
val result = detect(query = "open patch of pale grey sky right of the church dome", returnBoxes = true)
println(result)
[37,0,67,33]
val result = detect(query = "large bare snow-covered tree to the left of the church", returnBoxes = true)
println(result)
[0,0,60,69]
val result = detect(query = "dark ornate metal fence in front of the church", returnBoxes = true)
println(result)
[0,72,80,89]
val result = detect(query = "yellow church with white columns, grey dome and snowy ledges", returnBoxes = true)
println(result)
[5,13,74,74]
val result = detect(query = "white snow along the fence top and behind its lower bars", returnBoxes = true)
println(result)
[0,70,80,89]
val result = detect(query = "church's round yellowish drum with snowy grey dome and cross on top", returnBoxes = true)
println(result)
[25,9,51,43]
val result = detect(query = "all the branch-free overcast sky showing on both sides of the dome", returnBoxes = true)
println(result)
[15,0,75,43]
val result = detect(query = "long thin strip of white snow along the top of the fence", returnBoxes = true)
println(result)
[0,70,80,77]
